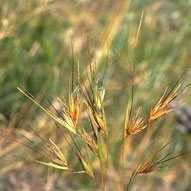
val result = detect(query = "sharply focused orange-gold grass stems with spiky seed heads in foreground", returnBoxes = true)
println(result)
[18,14,190,191]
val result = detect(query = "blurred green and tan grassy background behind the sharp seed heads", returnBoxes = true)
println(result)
[0,0,191,191]
